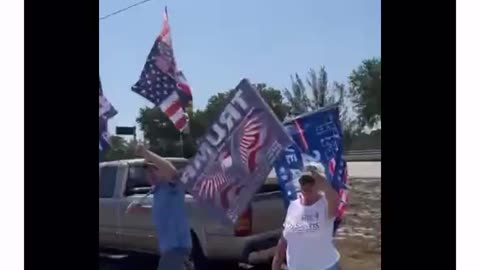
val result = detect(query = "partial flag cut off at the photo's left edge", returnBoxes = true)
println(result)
[98,77,118,160]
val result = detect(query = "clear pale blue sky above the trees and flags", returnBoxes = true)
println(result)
[99,0,381,133]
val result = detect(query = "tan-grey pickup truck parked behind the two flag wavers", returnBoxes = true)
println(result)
[99,158,285,269]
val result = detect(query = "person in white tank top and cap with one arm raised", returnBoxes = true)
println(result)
[272,168,340,270]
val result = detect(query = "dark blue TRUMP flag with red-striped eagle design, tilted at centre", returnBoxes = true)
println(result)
[180,79,293,223]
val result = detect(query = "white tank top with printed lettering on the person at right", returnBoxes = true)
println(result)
[283,195,340,270]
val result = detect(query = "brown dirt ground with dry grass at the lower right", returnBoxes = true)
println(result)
[336,178,382,270]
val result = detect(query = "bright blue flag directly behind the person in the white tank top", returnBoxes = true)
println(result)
[275,106,347,217]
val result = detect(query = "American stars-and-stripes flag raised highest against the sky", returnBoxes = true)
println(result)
[132,8,192,131]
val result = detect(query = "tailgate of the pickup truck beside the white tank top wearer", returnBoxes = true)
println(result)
[252,191,286,234]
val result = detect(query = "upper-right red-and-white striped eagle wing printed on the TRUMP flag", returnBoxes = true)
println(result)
[239,112,262,173]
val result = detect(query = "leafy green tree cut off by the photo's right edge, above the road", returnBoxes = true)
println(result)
[349,58,382,127]
